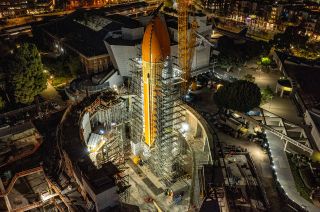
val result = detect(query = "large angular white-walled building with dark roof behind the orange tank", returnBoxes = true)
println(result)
[55,7,212,100]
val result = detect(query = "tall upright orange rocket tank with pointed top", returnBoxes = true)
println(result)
[142,16,170,147]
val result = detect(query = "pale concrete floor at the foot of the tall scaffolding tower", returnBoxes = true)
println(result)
[127,159,191,211]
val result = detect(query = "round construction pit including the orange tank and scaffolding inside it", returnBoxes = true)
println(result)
[55,5,218,211]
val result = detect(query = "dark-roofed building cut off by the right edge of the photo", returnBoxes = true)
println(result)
[274,52,320,149]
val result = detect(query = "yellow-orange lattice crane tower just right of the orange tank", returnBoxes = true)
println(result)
[178,0,198,93]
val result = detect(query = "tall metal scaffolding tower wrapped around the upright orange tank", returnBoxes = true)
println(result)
[130,58,184,186]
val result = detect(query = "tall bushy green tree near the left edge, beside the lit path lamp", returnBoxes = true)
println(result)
[9,43,46,104]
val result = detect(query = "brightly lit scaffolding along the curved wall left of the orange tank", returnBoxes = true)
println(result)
[79,93,130,202]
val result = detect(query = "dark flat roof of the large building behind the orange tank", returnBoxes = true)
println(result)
[41,4,144,57]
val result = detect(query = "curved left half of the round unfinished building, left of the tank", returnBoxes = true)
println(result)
[55,91,133,212]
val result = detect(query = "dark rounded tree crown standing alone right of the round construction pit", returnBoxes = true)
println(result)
[214,80,261,112]
